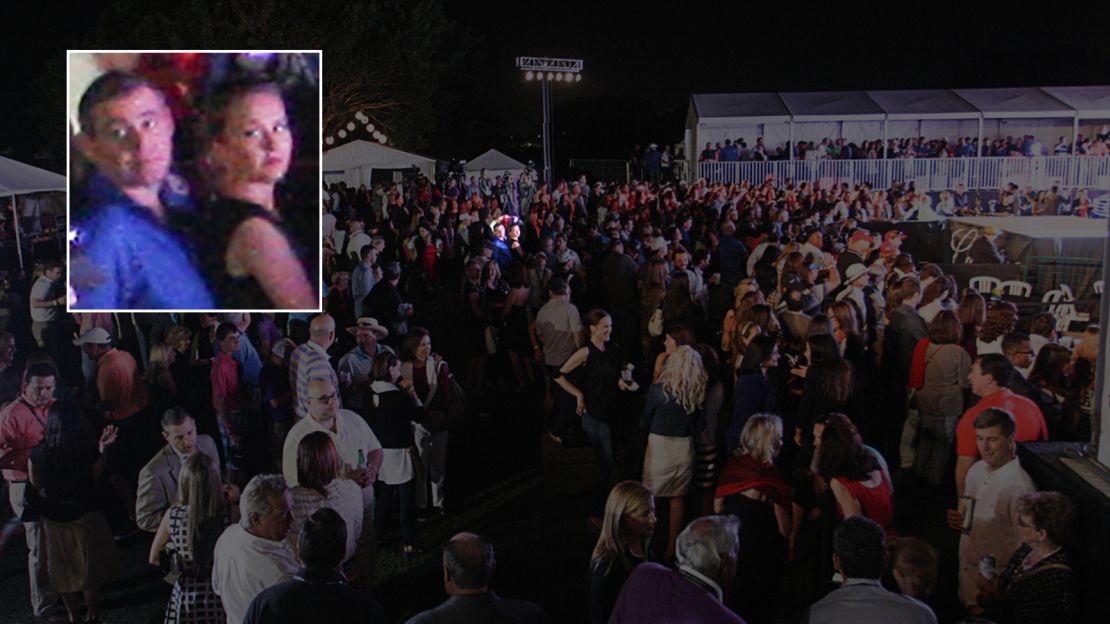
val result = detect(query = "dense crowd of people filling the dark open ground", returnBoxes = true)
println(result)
[0,152,1099,623]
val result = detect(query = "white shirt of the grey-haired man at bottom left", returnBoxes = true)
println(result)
[212,524,300,624]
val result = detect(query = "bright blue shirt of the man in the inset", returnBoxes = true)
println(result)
[70,175,215,310]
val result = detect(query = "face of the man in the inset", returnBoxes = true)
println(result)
[78,87,174,190]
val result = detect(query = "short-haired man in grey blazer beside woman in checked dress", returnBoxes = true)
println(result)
[135,407,227,533]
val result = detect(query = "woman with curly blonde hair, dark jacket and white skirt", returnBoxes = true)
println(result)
[639,346,708,556]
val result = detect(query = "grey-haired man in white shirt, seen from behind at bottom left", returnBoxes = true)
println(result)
[212,474,300,624]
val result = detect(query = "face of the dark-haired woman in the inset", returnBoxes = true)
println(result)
[209,91,293,184]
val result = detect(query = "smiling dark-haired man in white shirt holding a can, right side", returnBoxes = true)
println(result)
[948,407,1037,615]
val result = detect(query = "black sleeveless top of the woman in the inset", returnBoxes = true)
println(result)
[195,198,319,310]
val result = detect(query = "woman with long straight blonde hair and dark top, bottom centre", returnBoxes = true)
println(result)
[589,481,655,624]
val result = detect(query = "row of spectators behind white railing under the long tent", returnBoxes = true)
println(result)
[692,127,1110,167]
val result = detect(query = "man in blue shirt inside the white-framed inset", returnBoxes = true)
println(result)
[71,71,215,310]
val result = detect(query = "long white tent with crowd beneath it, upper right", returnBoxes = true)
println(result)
[686,87,1110,163]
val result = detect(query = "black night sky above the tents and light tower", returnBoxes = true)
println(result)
[0,0,1110,167]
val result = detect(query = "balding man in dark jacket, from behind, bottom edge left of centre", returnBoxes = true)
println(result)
[406,533,544,624]
